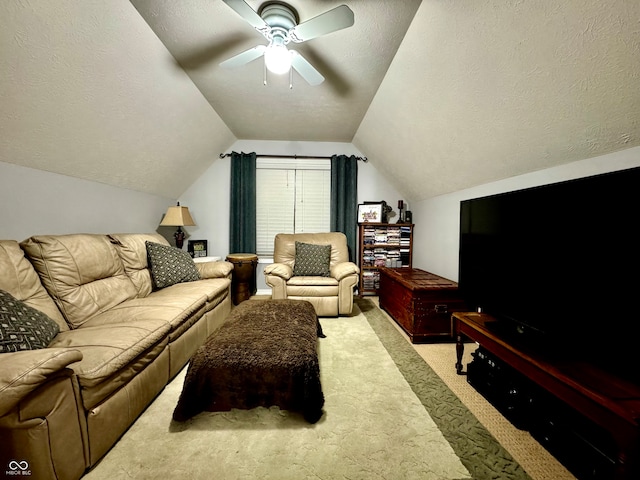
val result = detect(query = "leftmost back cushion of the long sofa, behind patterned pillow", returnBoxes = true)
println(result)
[0,240,69,331]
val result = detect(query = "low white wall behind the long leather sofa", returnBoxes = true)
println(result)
[0,162,175,241]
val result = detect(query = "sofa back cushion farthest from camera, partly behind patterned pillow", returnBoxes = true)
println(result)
[108,233,169,297]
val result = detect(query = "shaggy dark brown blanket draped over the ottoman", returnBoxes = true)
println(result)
[173,300,324,423]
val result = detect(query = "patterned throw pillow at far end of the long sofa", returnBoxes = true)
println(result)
[145,240,200,288]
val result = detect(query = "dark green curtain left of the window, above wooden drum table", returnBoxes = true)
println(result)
[229,152,256,253]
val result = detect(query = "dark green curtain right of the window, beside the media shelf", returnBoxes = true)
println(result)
[331,155,358,262]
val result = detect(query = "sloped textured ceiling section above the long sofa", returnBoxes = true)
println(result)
[0,0,235,198]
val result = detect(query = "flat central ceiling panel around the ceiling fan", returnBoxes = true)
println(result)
[131,0,420,142]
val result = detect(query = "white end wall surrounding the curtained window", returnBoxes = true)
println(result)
[180,140,403,291]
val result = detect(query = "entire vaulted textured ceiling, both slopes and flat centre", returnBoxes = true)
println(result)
[0,0,640,201]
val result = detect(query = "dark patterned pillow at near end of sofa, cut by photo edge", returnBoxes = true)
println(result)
[0,290,60,353]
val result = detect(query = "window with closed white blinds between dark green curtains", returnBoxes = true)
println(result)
[256,158,331,256]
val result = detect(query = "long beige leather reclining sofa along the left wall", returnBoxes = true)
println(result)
[0,234,233,479]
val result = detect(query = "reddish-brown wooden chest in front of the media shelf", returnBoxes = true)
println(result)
[379,267,468,343]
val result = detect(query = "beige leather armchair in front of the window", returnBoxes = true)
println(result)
[264,232,360,317]
